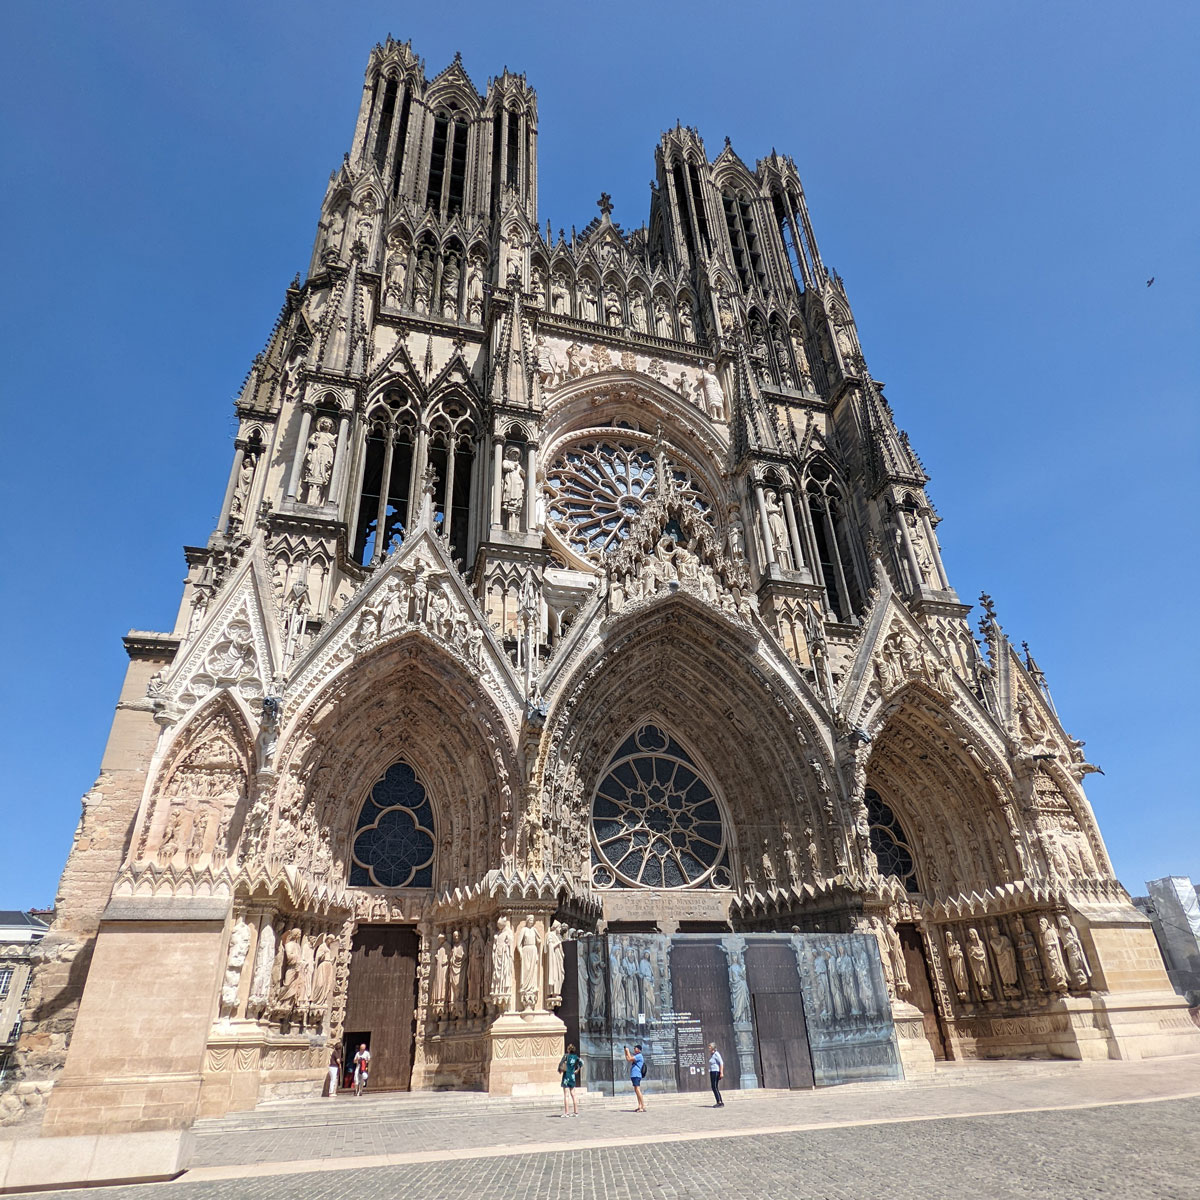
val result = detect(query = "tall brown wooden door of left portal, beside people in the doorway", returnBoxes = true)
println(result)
[344,925,418,1092]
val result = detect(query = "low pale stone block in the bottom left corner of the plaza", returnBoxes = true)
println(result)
[0,1129,192,1194]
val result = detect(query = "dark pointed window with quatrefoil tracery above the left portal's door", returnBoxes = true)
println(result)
[349,762,434,888]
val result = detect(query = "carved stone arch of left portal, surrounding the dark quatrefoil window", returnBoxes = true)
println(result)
[271,632,521,889]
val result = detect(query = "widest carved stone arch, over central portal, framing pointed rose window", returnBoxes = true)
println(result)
[542,595,833,880]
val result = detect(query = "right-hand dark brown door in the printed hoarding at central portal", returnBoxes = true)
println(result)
[745,941,812,1088]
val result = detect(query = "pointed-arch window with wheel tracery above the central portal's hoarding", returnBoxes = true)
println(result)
[592,725,732,888]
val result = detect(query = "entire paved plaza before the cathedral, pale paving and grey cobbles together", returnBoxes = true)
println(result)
[18,1056,1200,1200]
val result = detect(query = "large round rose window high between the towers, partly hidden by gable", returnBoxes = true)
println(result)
[546,442,709,560]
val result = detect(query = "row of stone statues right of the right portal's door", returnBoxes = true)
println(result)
[943,913,1092,1003]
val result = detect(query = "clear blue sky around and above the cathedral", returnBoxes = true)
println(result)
[0,0,1200,908]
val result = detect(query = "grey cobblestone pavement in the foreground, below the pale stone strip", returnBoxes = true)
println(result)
[28,1099,1200,1200]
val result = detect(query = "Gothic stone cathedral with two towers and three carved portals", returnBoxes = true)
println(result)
[11,38,1200,1135]
